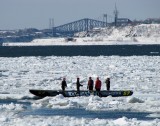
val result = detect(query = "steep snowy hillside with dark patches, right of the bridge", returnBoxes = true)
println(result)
[75,24,160,42]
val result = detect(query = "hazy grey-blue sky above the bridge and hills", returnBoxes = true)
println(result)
[0,0,160,30]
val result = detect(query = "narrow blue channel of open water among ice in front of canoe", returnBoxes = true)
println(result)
[0,99,158,120]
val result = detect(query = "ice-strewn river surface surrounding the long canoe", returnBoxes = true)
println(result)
[0,56,160,126]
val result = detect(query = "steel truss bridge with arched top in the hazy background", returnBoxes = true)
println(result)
[52,18,106,37]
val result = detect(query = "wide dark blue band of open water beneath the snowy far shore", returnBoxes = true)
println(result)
[0,45,160,57]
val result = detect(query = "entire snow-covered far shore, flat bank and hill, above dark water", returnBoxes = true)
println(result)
[3,24,160,46]
